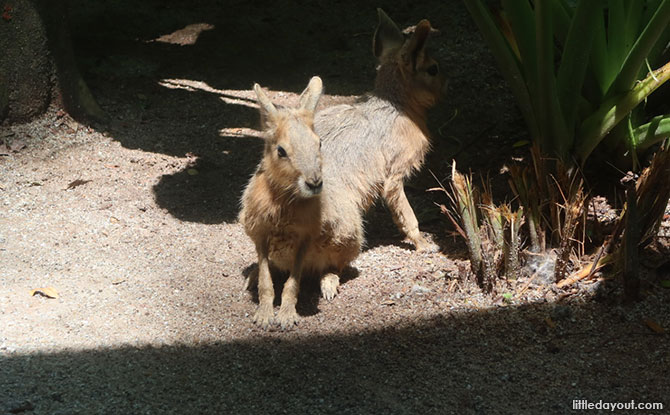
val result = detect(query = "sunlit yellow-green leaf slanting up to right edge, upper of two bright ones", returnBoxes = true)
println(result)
[575,62,670,163]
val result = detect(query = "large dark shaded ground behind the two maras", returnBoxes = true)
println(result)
[70,0,518,229]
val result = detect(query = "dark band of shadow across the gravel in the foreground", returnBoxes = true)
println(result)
[0,303,670,414]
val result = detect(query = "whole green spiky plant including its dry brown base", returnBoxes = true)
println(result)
[464,0,670,290]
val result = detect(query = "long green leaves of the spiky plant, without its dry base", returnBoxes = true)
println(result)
[464,0,670,166]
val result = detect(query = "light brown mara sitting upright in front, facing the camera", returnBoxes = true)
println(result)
[240,77,363,329]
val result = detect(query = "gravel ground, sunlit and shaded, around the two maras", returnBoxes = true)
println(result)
[0,2,670,414]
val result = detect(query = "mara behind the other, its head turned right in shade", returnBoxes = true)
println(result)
[314,9,445,254]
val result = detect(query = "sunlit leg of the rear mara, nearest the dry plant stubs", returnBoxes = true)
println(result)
[382,176,437,251]
